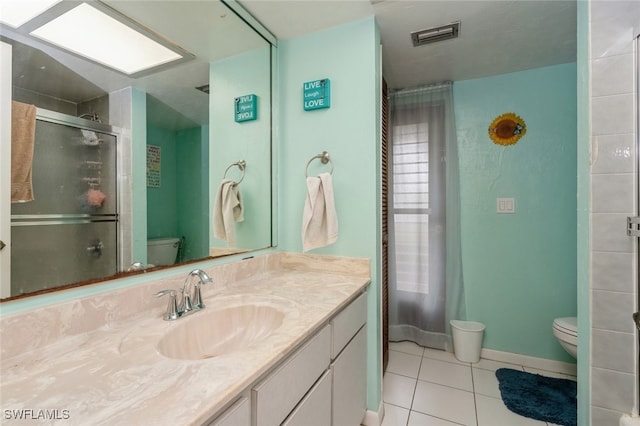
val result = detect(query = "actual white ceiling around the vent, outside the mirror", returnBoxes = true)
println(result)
[240,0,576,88]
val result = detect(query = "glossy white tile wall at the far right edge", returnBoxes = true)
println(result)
[590,0,640,426]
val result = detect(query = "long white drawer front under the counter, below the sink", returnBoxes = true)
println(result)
[251,325,331,426]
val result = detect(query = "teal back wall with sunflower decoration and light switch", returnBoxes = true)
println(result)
[454,64,577,362]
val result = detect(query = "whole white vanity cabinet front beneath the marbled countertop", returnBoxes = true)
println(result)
[210,293,367,426]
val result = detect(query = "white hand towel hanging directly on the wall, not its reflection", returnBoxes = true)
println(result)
[302,173,338,251]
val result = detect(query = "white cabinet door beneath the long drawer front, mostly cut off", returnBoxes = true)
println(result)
[282,371,331,426]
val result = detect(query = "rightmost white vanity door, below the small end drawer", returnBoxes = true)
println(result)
[331,325,367,426]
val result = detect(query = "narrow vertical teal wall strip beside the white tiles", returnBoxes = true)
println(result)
[577,0,591,425]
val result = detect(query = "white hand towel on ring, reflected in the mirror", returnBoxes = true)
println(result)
[213,179,244,247]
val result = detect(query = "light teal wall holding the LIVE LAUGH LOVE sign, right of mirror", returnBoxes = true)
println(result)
[278,18,382,411]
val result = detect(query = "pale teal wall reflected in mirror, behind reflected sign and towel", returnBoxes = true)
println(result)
[209,42,271,249]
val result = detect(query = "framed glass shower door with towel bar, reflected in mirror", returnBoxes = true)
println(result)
[11,110,118,296]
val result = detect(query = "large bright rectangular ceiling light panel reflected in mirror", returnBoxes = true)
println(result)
[31,3,183,75]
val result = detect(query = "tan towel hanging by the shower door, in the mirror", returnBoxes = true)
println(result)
[11,101,36,203]
